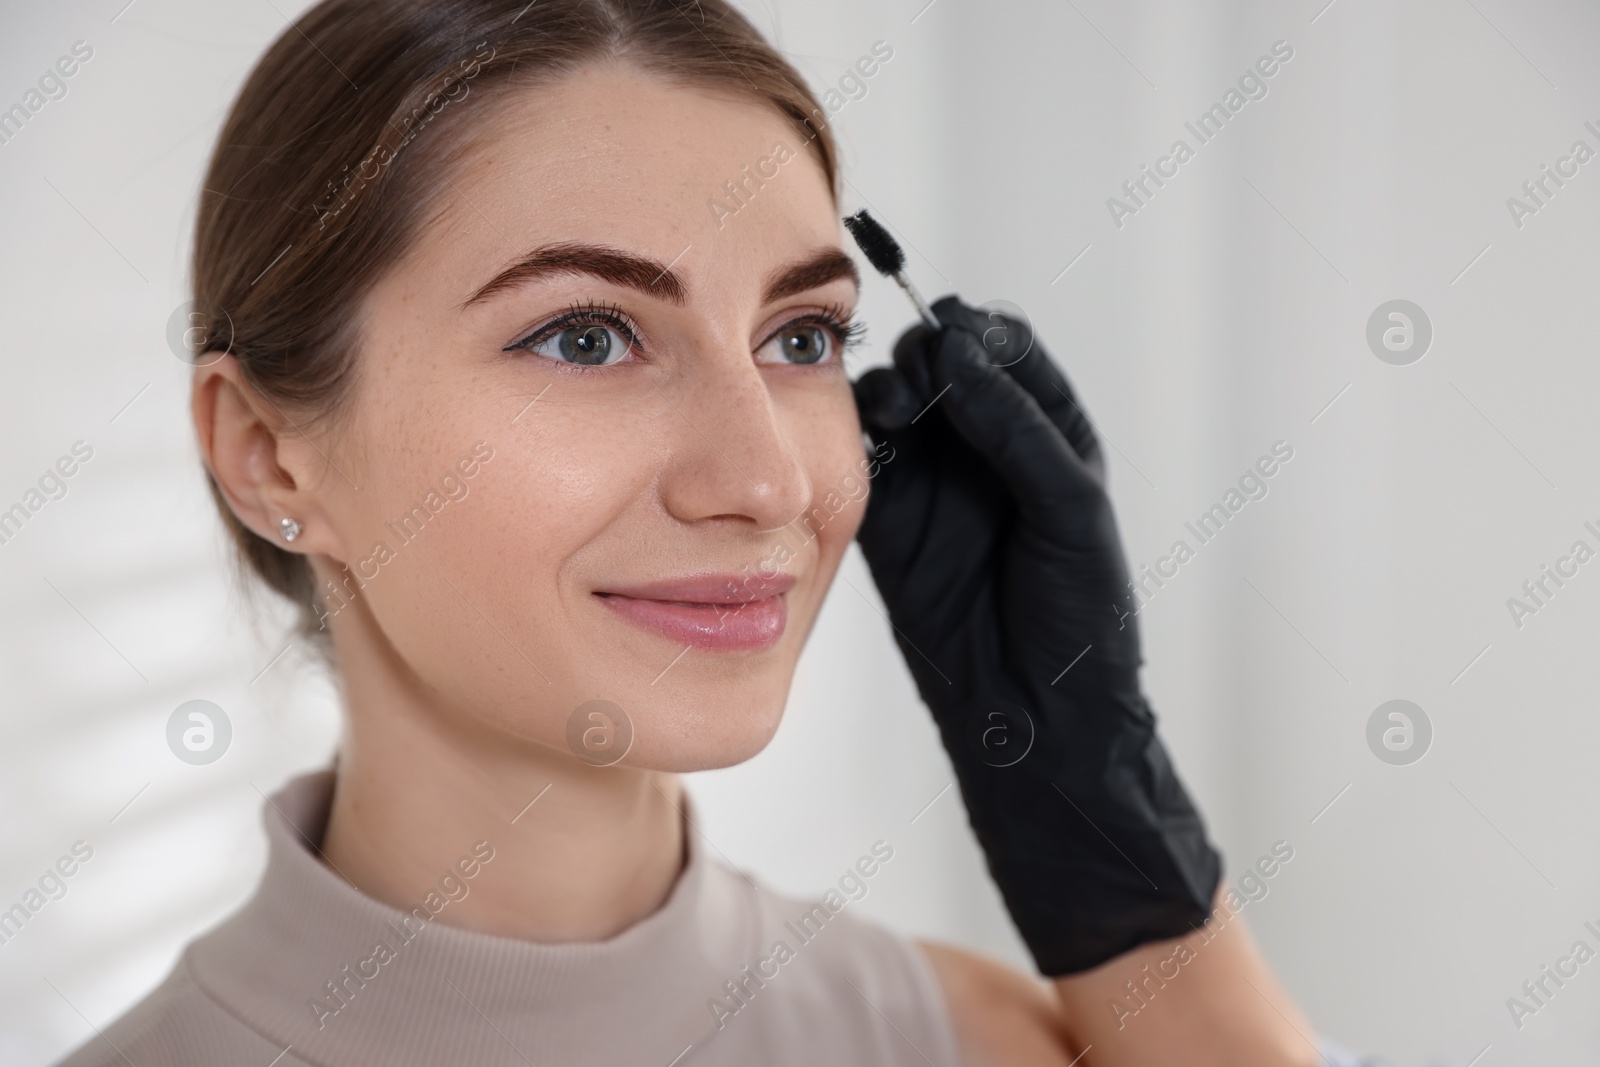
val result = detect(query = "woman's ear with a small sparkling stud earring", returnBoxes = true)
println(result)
[190,355,347,560]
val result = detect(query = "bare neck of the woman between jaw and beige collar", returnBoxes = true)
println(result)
[322,607,685,942]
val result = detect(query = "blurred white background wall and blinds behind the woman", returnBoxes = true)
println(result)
[0,0,1600,1067]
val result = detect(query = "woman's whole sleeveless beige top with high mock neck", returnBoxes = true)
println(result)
[61,771,960,1067]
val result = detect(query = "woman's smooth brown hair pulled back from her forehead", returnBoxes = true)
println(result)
[194,0,838,635]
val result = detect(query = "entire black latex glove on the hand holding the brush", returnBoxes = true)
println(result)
[854,296,1221,976]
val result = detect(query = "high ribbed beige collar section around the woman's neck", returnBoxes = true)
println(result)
[184,771,758,1067]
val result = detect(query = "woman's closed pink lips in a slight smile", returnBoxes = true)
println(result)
[595,574,795,651]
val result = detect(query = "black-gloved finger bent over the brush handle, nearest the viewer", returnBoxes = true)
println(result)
[928,330,1115,544]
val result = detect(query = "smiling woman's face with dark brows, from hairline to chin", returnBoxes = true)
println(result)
[308,66,867,769]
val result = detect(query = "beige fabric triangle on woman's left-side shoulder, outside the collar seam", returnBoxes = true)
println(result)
[56,960,304,1067]
